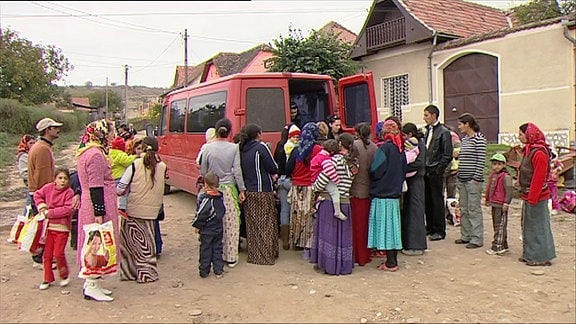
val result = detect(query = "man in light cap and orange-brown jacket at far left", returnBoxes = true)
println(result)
[28,118,62,269]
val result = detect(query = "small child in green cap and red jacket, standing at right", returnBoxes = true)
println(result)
[486,153,514,255]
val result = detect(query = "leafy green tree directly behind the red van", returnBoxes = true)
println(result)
[265,26,359,82]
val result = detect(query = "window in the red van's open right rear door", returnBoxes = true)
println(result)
[344,83,372,126]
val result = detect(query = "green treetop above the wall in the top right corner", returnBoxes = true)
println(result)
[512,0,576,24]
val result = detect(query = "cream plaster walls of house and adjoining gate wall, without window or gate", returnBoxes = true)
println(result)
[362,23,576,143]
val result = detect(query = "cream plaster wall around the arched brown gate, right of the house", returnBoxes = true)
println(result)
[432,24,576,141]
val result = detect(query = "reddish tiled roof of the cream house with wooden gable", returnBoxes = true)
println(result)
[397,0,509,37]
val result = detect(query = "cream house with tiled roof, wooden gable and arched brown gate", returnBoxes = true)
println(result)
[352,0,576,146]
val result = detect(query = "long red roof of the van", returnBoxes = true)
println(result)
[161,72,332,97]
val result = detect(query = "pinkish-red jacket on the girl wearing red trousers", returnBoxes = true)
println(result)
[34,182,74,231]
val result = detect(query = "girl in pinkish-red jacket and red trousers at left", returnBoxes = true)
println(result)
[34,168,74,290]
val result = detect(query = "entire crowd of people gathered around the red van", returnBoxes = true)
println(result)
[12,105,556,301]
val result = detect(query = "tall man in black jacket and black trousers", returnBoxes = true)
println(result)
[424,105,452,241]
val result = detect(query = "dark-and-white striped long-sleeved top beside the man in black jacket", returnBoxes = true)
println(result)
[458,132,486,182]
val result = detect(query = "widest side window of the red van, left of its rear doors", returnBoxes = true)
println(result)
[186,91,228,133]
